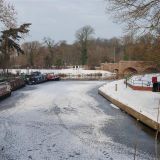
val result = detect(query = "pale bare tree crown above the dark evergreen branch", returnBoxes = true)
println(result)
[0,0,16,28]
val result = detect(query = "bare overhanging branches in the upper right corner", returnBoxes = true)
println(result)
[106,0,160,34]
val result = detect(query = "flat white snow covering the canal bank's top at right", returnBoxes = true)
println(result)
[100,80,160,123]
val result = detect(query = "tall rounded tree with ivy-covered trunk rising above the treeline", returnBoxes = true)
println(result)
[76,26,94,65]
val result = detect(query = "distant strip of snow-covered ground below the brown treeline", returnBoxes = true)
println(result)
[6,68,112,77]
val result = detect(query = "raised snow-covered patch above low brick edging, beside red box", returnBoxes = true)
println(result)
[128,73,160,87]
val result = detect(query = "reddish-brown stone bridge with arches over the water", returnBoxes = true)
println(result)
[101,61,160,75]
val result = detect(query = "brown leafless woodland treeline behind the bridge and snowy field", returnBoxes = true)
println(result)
[0,35,160,68]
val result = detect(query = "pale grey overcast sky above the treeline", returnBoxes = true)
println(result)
[9,0,122,43]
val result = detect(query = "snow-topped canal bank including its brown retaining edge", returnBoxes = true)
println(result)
[98,80,160,131]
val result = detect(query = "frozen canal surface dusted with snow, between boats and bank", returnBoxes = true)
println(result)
[0,81,160,160]
